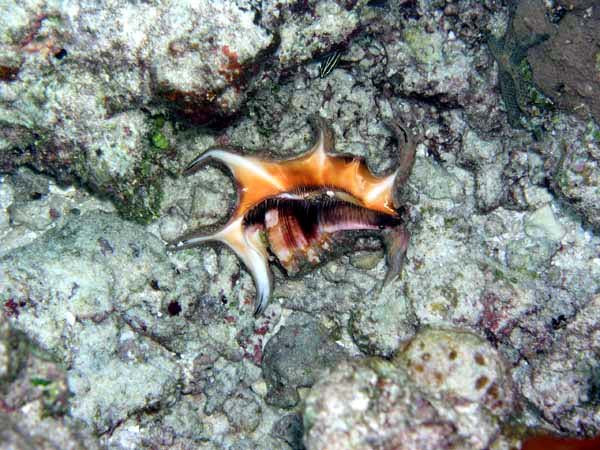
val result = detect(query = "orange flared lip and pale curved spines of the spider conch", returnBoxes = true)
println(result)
[176,117,414,313]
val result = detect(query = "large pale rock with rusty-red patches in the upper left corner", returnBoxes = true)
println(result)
[0,0,272,220]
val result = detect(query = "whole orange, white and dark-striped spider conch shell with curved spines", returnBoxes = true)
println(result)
[173,116,415,315]
